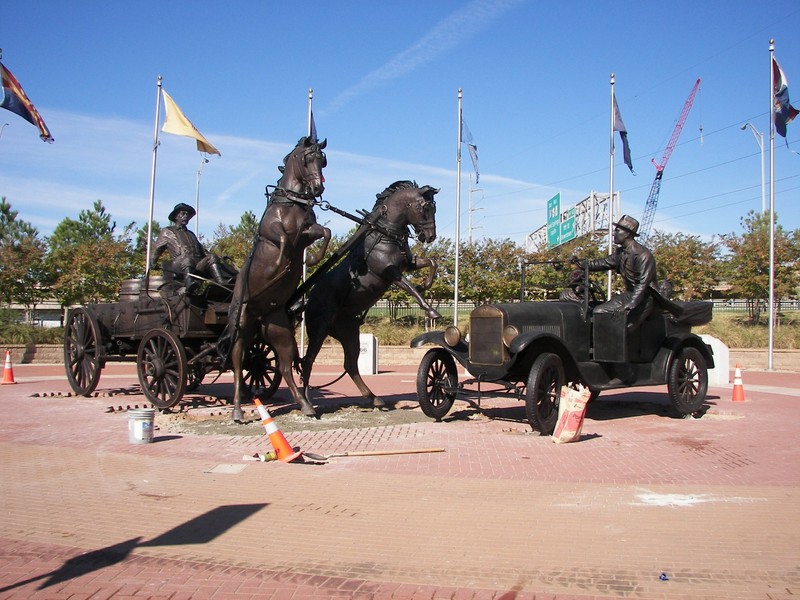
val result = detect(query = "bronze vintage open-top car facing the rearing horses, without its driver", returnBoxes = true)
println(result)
[411,264,714,435]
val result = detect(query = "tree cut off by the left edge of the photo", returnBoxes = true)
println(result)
[0,198,49,318]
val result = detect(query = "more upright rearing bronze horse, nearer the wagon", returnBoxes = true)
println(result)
[223,137,331,421]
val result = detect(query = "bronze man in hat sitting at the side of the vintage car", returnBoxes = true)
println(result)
[576,215,657,331]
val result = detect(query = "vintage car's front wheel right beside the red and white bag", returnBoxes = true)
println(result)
[525,352,564,435]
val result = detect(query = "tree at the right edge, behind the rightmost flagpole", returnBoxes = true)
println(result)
[721,211,800,323]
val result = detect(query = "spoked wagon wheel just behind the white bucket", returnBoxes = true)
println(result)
[136,329,188,408]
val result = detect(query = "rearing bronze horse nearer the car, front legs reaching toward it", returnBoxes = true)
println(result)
[301,181,440,407]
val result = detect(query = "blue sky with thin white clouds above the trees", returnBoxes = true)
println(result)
[0,0,800,244]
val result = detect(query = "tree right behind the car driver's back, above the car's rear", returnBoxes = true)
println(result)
[648,230,720,300]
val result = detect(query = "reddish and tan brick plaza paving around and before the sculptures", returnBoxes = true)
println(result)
[0,365,800,600]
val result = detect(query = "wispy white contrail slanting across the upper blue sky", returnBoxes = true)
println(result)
[325,0,525,113]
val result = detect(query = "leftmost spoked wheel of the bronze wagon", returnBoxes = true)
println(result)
[64,308,104,396]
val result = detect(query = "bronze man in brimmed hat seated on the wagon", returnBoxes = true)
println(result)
[150,202,236,293]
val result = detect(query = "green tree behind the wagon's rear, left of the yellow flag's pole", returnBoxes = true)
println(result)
[48,200,138,306]
